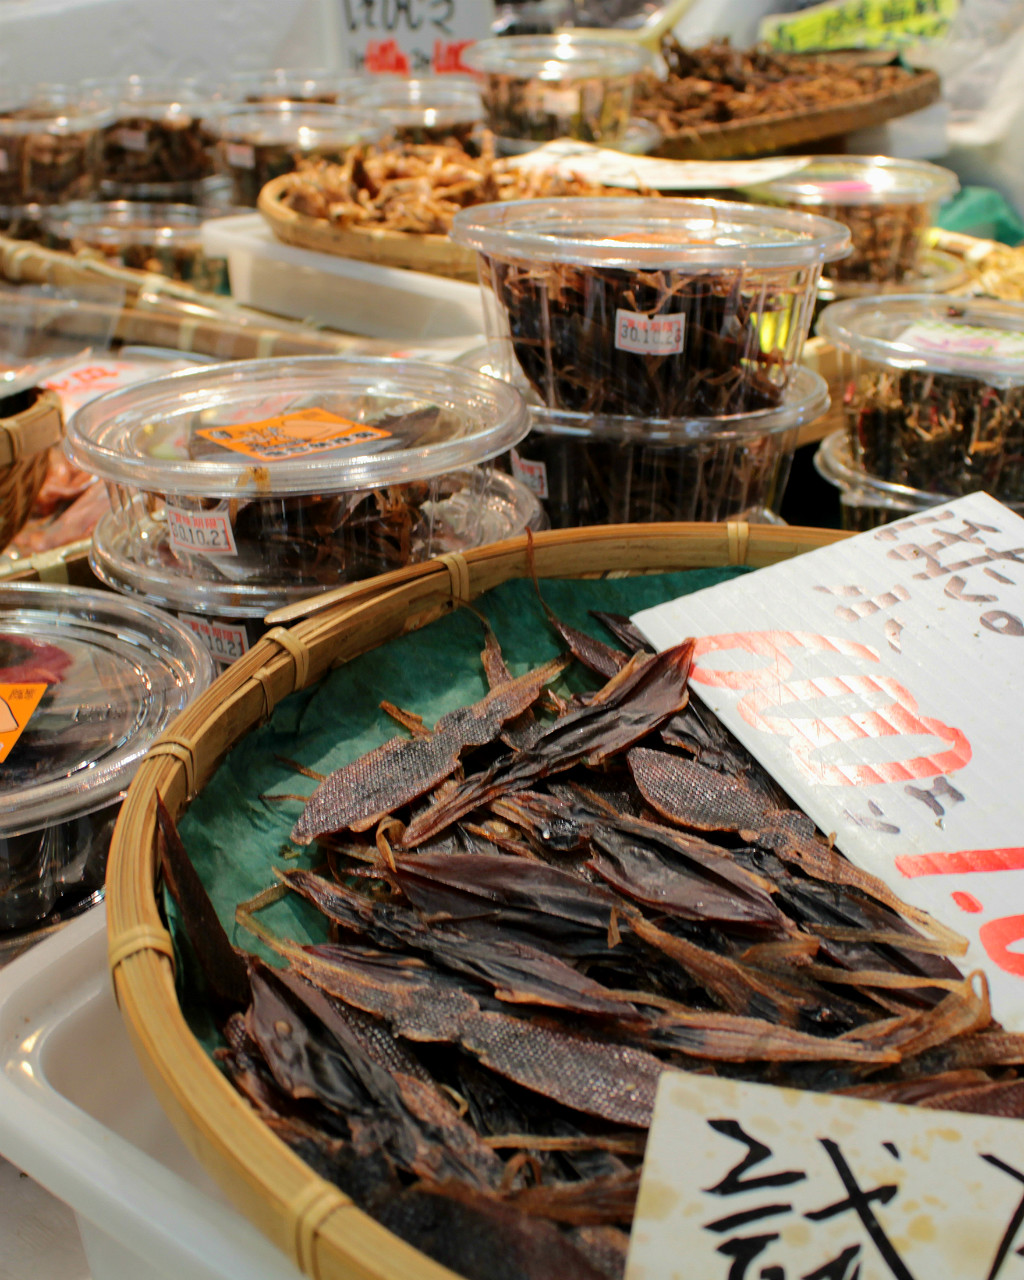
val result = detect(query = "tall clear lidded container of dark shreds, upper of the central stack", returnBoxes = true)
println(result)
[452,196,850,419]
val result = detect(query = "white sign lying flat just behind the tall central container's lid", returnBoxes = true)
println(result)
[508,138,810,191]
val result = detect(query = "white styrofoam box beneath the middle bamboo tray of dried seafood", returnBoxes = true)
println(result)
[202,212,484,342]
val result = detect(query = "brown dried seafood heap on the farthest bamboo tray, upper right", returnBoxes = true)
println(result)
[634,37,918,137]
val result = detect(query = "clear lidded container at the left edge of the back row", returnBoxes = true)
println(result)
[0,84,110,209]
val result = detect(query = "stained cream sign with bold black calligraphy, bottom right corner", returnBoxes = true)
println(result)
[626,1071,1024,1280]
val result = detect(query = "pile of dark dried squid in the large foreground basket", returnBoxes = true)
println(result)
[161,591,1024,1280]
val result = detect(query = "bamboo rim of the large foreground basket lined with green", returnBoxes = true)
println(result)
[106,522,849,1280]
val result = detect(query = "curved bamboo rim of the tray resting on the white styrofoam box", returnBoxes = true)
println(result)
[259,174,476,283]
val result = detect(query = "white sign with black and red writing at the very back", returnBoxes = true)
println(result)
[325,0,494,76]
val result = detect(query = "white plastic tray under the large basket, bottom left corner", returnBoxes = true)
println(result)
[0,906,301,1280]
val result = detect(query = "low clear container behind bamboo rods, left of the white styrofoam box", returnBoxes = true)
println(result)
[42,200,228,293]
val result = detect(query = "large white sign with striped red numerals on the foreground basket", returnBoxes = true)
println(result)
[634,494,1024,1029]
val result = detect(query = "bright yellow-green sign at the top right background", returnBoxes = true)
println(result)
[758,0,960,52]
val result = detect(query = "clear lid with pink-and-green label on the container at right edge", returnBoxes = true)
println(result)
[818,293,1024,387]
